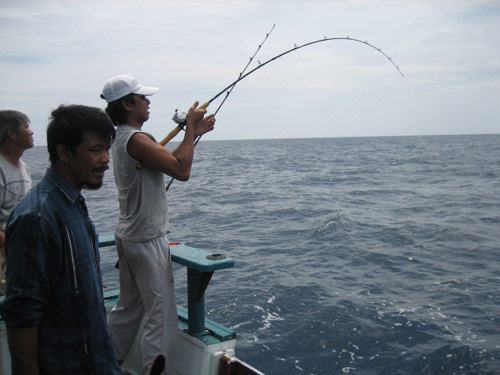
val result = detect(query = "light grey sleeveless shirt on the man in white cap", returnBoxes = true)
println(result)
[111,125,168,241]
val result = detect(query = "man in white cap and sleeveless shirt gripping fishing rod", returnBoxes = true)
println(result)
[101,75,215,374]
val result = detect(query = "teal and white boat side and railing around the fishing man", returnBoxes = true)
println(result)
[0,235,264,375]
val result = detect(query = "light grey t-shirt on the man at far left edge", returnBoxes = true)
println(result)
[0,156,31,232]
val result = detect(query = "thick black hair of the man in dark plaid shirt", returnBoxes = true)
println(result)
[47,105,116,164]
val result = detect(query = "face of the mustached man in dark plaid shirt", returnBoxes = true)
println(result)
[66,133,110,190]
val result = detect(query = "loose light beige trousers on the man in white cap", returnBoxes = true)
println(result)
[109,236,177,375]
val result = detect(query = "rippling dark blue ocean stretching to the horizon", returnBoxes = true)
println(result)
[23,135,500,375]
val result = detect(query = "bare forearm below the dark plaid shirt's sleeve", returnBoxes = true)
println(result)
[7,326,39,375]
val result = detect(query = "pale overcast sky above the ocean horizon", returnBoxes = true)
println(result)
[0,0,500,145]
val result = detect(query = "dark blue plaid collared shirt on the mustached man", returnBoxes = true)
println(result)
[0,169,121,375]
